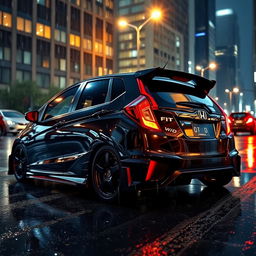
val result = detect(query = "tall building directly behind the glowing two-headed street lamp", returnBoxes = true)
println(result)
[115,0,189,72]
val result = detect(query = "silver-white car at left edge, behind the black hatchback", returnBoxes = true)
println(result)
[0,109,28,135]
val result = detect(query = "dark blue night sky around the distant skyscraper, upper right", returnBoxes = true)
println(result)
[216,0,254,104]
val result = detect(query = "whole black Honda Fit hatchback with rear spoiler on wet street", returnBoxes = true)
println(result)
[9,68,240,201]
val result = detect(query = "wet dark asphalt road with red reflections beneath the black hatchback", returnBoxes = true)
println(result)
[0,135,256,256]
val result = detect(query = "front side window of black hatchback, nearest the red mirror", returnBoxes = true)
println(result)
[42,86,79,120]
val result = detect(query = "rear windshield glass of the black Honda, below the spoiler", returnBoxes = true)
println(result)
[147,81,221,114]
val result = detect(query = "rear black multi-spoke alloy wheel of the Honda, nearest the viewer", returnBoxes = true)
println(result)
[91,146,121,202]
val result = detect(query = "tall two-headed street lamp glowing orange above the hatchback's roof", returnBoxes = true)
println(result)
[118,9,162,69]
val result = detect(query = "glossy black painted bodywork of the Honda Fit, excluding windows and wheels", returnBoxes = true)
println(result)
[9,70,240,194]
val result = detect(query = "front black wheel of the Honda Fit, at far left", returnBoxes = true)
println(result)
[13,145,28,181]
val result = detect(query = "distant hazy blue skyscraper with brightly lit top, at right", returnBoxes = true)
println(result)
[215,9,242,112]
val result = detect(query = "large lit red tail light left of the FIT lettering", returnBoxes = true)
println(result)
[125,95,161,131]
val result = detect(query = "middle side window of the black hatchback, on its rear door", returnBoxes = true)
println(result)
[76,79,109,109]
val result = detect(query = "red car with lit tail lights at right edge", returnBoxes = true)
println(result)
[229,112,256,135]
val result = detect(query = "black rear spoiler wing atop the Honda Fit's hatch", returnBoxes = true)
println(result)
[135,67,216,98]
